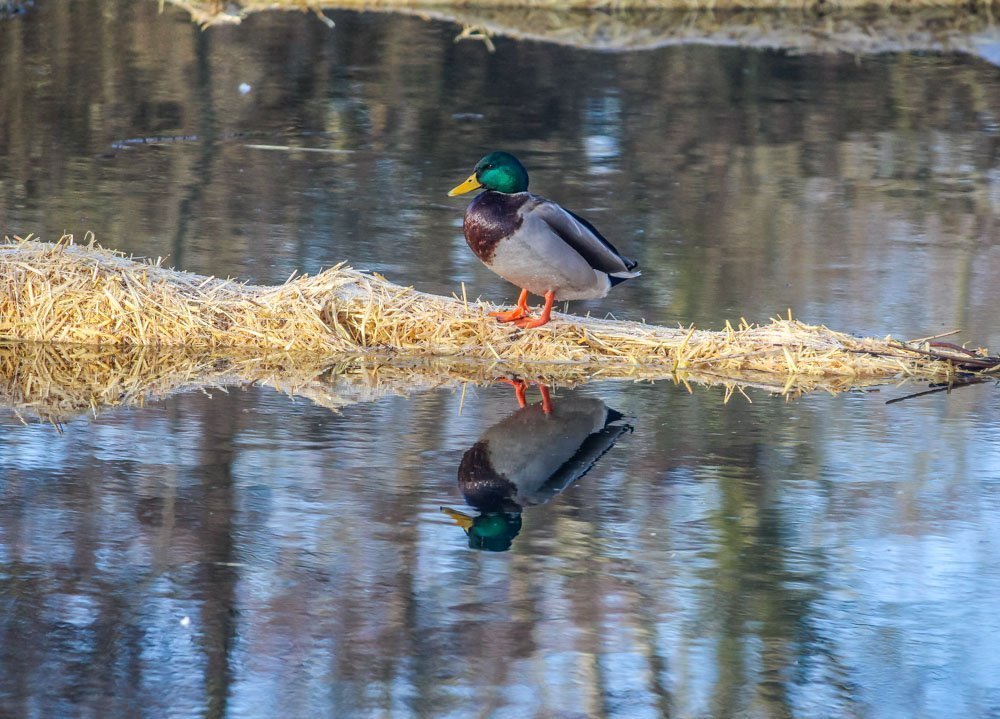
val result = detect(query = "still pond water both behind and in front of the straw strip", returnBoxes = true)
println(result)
[0,0,1000,718]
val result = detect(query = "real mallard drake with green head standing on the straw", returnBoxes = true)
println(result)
[448,152,639,328]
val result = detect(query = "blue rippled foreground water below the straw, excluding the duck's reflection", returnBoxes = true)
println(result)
[0,384,1000,716]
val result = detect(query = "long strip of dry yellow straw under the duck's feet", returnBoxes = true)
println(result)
[0,235,996,386]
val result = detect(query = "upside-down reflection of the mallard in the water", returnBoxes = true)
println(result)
[441,379,632,552]
